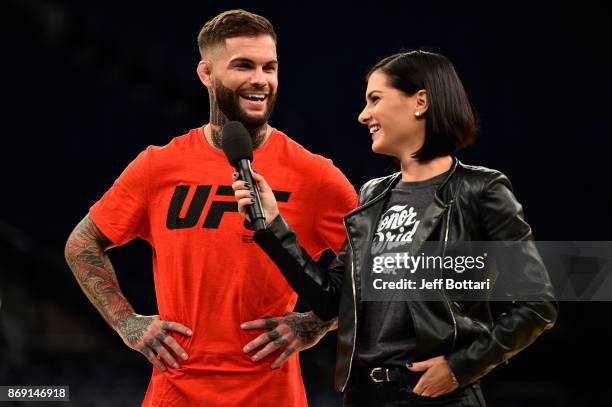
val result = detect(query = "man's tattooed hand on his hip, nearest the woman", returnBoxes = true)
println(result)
[240,312,338,369]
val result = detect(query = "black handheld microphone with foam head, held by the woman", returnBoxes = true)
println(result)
[221,121,266,231]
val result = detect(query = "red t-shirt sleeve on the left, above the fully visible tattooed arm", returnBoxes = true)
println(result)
[89,149,150,246]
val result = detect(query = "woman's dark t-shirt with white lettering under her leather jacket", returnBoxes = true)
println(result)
[354,172,448,366]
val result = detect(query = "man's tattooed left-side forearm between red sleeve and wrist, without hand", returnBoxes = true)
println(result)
[65,215,134,327]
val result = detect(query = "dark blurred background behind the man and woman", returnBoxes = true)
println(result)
[0,1,612,407]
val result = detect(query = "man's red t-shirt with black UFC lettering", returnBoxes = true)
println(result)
[90,128,357,407]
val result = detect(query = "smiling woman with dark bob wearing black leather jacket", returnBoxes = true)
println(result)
[233,51,557,406]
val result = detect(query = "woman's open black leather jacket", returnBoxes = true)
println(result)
[255,159,557,391]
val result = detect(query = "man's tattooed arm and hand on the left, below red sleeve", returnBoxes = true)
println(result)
[65,214,191,370]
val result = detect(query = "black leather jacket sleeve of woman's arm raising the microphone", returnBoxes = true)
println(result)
[254,215,348,320]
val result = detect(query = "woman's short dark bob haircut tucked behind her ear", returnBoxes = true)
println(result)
[366,51,478,162]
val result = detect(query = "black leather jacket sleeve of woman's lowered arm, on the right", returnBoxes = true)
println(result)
[447,173,558,386]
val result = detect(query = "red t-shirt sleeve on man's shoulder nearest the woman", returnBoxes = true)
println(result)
[313,160,357,257]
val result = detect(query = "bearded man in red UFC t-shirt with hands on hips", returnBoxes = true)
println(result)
[66,10,356,406]
